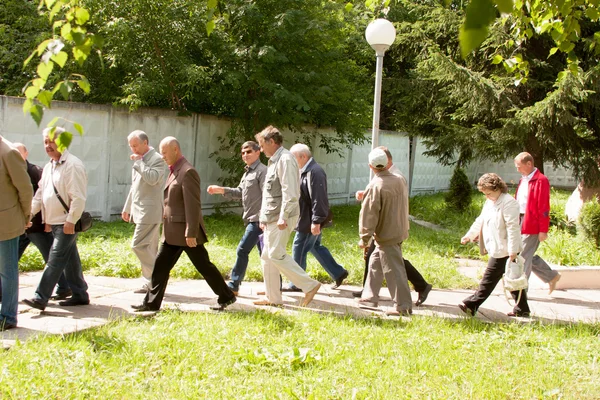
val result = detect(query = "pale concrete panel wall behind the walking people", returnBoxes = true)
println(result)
[0,96,576,220]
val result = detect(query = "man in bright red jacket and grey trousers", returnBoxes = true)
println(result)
[515,153,560,306]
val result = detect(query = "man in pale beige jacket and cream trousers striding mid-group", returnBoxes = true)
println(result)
[254,126,321,306]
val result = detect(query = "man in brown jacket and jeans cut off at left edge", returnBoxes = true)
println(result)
[0,136,33,331]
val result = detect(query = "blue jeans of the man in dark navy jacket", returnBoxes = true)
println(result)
[292,232,346,281]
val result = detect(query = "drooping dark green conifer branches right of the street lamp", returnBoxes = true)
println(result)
[382,1,600,186]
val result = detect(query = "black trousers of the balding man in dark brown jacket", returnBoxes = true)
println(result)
[144,242,235,310]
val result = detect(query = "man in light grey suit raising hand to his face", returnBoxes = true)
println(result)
[121,130,166,293]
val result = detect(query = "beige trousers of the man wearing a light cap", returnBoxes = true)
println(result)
[362,243,412,312]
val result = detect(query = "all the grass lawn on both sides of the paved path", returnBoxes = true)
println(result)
[8,190,600,399]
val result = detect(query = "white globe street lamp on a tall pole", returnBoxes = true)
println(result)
[365,18,396,156]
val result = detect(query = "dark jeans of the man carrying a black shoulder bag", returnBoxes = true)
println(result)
[35,225,90,305]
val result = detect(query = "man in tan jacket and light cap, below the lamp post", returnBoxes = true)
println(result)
[358,148,412,315]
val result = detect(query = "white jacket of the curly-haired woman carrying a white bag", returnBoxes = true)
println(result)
[465,193,523,258]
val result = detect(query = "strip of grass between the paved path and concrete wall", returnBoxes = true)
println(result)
[20,190,600,289]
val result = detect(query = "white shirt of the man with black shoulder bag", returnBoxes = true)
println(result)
[31,150,87,225]
